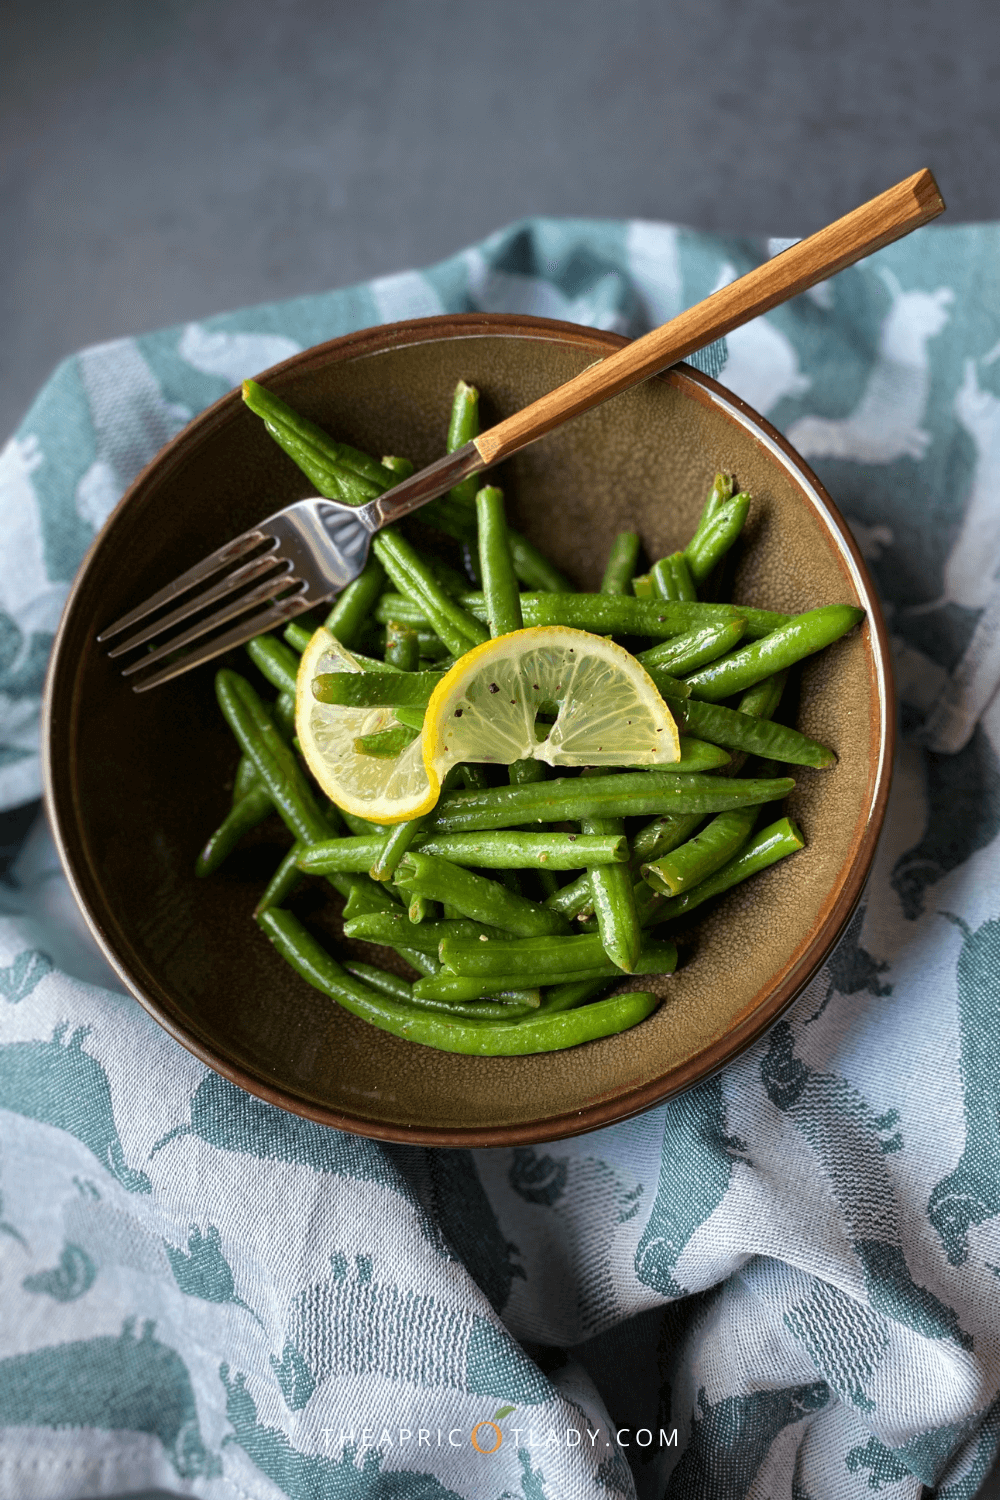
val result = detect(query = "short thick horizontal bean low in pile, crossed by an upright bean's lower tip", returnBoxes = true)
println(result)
[439,933,678,984]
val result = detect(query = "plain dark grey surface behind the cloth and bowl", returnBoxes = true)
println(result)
[7,0,1000,1500]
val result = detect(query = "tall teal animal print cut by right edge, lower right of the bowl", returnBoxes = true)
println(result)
[927,918,1000,1266]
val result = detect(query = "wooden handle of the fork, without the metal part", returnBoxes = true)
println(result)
[474,171,945,465]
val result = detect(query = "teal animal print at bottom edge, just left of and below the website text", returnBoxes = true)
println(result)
[219,1364,460,1500]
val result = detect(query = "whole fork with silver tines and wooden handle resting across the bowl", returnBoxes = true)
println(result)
[97,171,945,693]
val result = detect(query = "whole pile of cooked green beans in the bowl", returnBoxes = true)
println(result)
[196,381,862,1056]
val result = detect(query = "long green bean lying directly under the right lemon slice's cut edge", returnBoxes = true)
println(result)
[430,768,795,834]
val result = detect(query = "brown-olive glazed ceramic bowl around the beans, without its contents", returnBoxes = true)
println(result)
[45,315,892,1146]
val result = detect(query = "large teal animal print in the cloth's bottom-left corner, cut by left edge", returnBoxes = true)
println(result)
[0,1319,220,1479]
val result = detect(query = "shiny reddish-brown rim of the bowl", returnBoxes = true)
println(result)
[42,314,895,1148]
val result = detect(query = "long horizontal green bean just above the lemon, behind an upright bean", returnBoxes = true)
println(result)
[375,591,792,641]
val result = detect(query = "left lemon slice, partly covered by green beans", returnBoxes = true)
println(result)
[295,630,441,824]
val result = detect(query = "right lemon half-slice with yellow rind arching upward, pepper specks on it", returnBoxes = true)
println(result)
[421,626,681,785]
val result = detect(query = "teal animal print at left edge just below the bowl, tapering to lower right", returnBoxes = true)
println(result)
[0,1023,150,1193]
